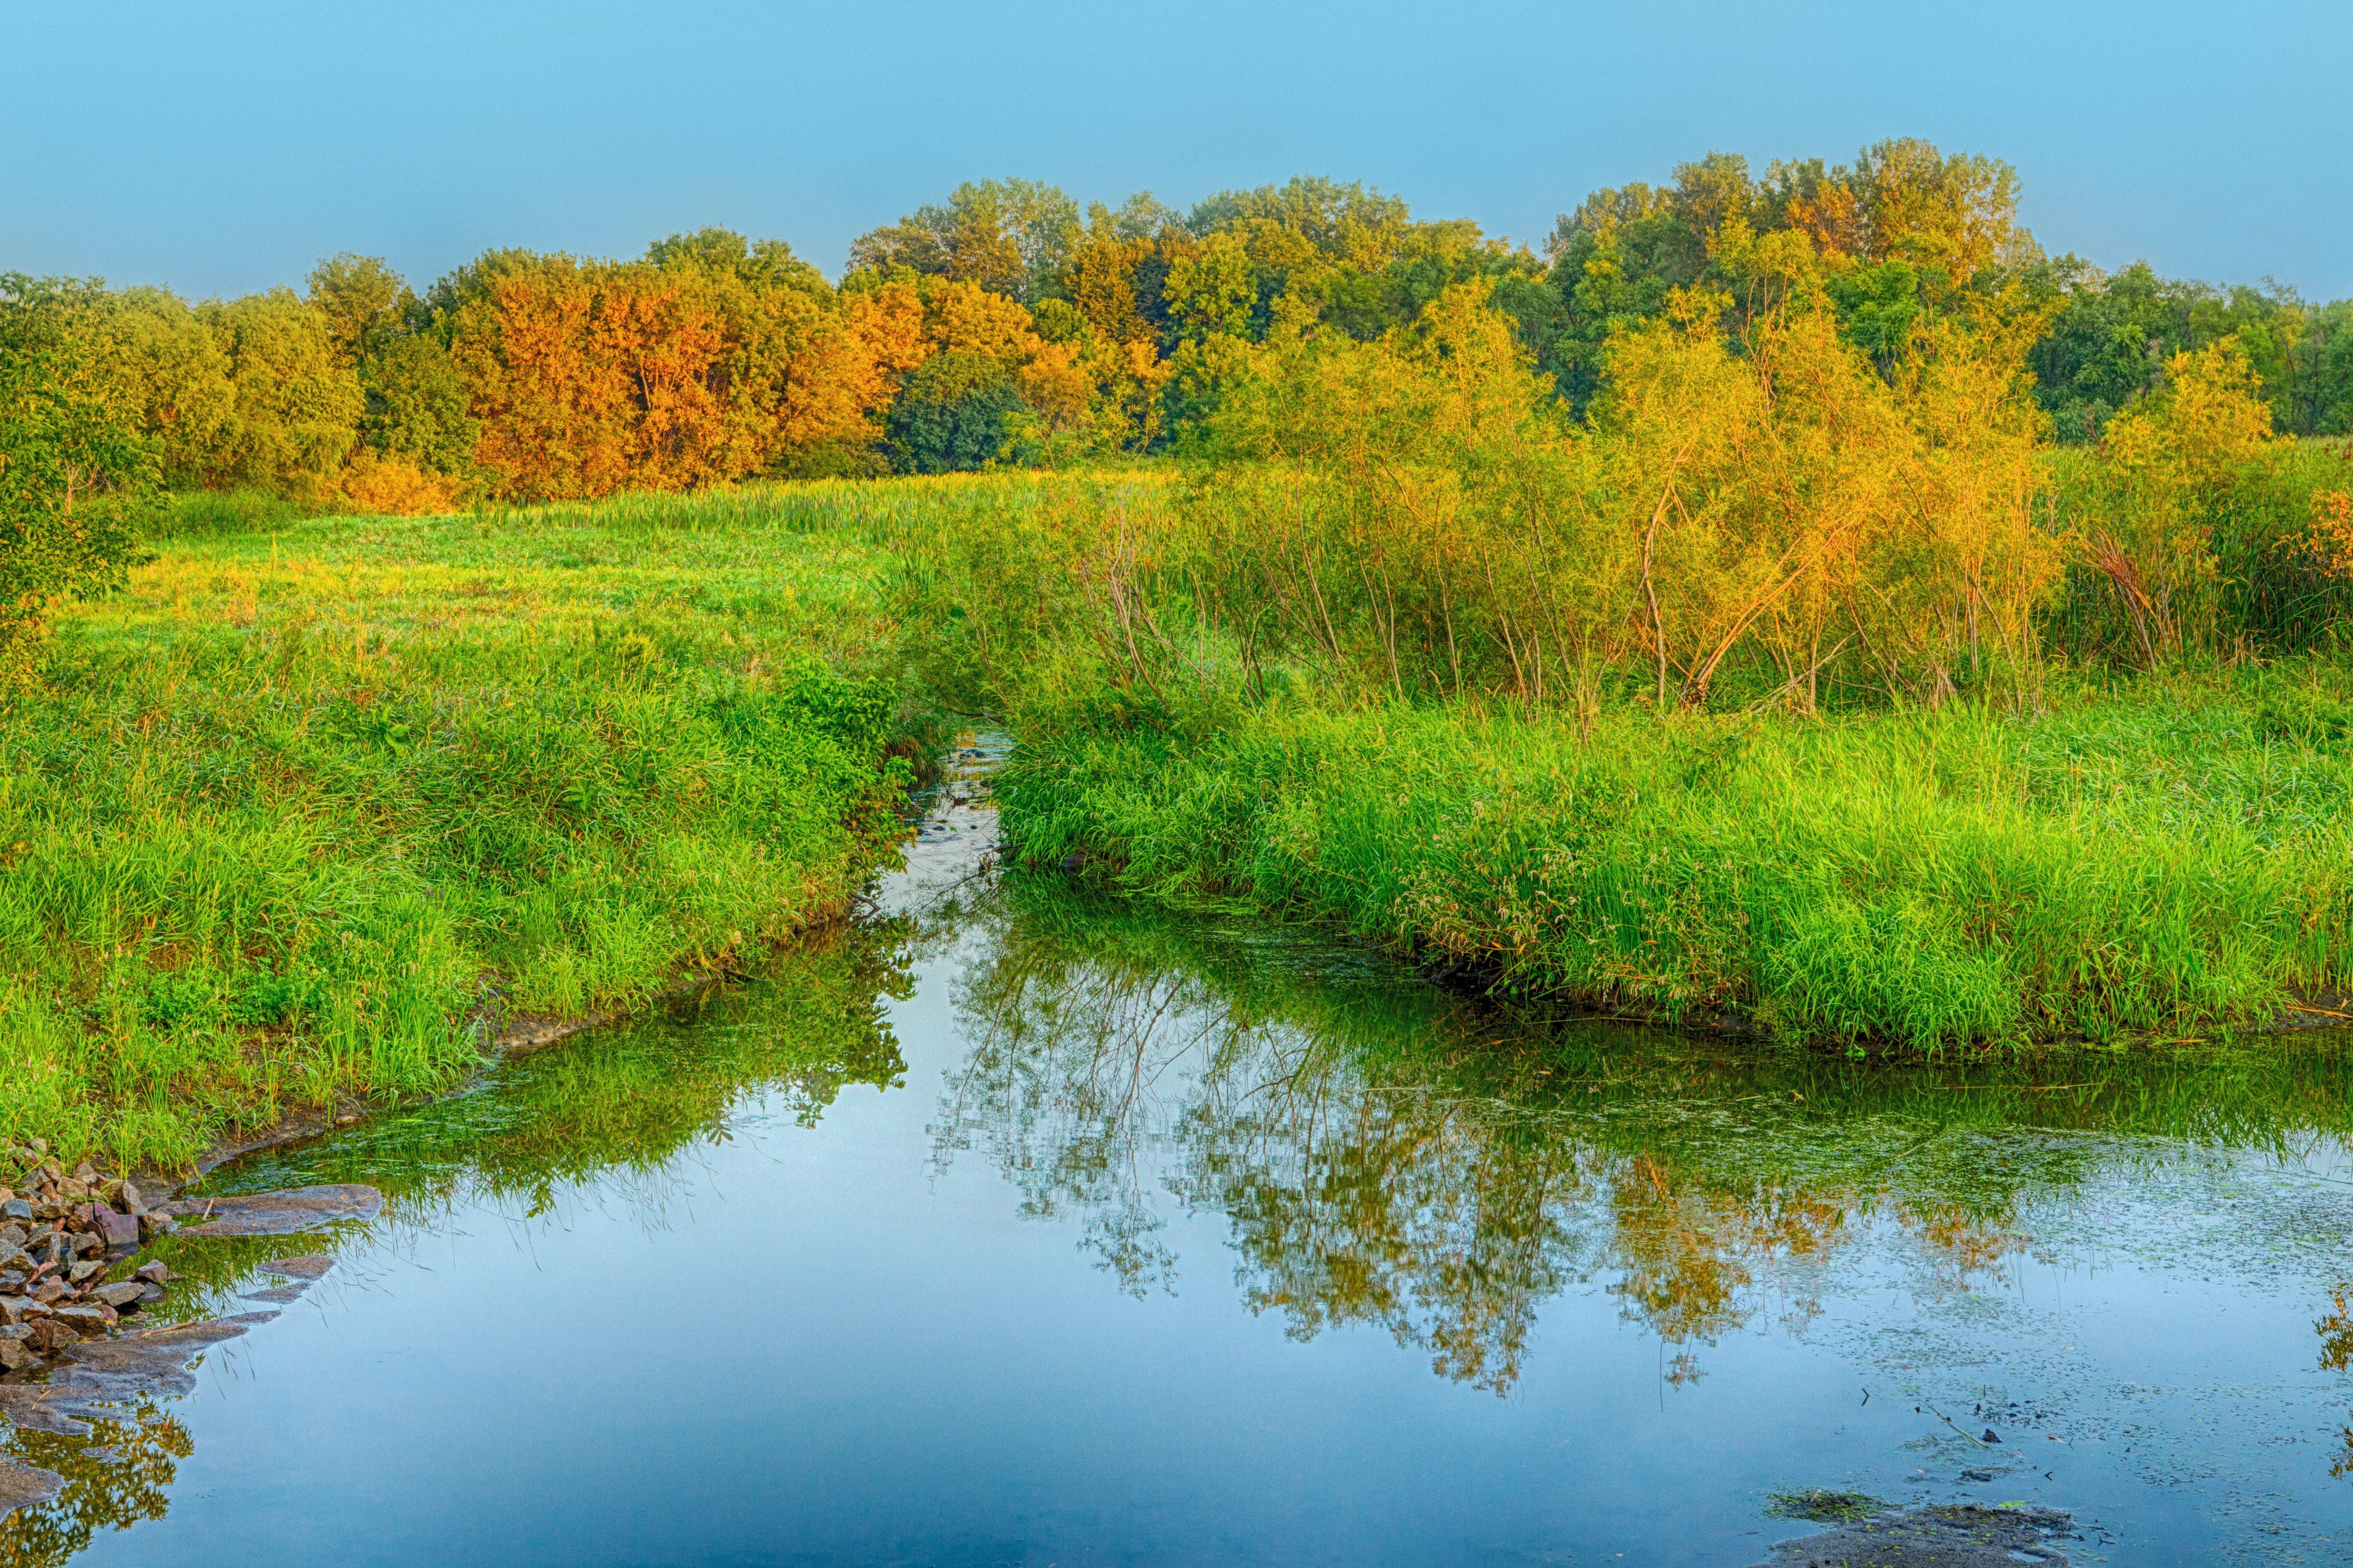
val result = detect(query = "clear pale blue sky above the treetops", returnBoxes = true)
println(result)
[0,0,2353,299]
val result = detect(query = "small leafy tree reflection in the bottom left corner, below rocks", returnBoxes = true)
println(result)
[0,1399,193,1568]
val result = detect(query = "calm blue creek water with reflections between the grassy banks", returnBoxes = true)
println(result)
[0,758,2353,1568]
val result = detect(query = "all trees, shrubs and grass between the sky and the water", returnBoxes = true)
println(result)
[0,141,2353,1168]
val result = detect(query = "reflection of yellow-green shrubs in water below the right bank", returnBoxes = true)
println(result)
[934,890,2164,1394]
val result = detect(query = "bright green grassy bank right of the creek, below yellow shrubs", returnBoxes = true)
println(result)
[1000,664,2353,1048]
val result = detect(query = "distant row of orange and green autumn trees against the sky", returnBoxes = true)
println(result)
[13,141,2353,511]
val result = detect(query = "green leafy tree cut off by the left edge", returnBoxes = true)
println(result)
[0,273,155,690]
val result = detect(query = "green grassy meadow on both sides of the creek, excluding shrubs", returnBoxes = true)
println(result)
[13,452,2353,1165]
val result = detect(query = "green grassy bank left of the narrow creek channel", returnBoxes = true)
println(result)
[0,483,1040,1163]
